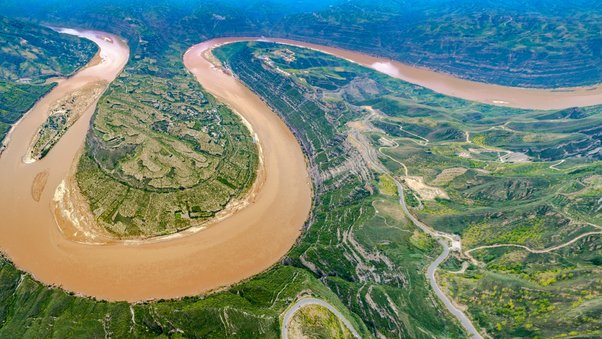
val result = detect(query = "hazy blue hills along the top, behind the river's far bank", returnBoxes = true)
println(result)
[0,0,602,88]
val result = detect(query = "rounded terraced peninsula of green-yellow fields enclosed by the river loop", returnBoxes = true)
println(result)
[76,61,258,238]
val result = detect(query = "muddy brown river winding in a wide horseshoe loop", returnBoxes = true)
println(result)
[0,30,602,301]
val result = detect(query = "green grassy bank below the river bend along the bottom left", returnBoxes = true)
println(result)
[0,259,366,338]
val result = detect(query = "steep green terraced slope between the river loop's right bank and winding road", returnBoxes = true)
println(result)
[215,43,463,337]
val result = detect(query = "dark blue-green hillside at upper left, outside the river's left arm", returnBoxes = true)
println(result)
[0,16,97,141]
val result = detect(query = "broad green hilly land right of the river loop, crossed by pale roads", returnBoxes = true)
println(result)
[218,43,602,337]
